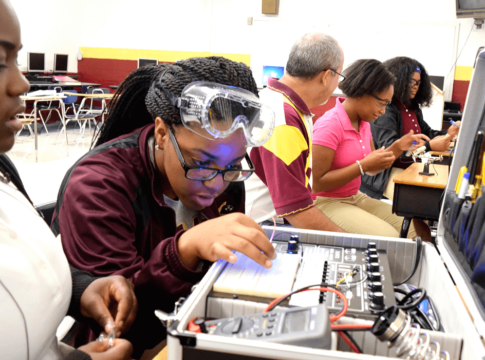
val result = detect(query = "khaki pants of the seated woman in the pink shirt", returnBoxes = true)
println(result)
[314,191,416,238]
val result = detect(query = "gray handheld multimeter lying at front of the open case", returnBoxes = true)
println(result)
[201,304,332,349]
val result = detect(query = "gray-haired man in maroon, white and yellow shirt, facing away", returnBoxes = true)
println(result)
[245,33,344,232]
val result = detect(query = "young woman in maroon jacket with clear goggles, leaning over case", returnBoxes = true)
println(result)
[52,57,276,354]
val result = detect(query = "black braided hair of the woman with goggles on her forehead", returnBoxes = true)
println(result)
[93,56,258,146]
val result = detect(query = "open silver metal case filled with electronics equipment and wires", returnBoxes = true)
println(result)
[161,52,485,360]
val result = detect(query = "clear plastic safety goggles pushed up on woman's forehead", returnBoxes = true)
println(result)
[164,81,275,147]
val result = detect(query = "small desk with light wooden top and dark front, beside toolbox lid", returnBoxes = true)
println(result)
[392,163,448,238]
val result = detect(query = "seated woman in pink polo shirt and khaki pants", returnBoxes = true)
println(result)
[312,59,430,238]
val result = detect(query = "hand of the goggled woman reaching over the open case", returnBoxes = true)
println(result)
[177,213,276,269]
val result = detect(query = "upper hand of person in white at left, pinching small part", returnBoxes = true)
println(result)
[81,275,138,337]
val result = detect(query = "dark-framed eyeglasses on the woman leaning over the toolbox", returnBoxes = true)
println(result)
[168,129,255,182]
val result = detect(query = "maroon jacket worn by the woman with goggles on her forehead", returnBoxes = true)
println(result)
[51,124,245,352]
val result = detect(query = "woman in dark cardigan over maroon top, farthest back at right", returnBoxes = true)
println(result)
[360,56,459,200]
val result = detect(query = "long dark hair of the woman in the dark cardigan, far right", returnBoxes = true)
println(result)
[384,56,433,110]
